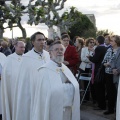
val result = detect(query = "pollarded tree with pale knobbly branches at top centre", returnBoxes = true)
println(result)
[28,0,66,28]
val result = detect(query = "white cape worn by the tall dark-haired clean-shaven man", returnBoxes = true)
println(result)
[14,50,50,120]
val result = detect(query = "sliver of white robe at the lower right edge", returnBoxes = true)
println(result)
[116,76,120,120]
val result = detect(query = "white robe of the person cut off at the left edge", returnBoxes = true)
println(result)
[0,53,6,114]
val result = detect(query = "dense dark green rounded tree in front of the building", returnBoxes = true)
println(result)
[64,8,96,39]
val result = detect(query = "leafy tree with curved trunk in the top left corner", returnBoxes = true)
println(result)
[0,0,26,38]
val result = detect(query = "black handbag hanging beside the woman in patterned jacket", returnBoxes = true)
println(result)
[95,64,105,83]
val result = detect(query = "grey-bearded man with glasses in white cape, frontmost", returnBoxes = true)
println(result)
[30,41,80,120]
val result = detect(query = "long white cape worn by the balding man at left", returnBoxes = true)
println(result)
[1,53,22,120]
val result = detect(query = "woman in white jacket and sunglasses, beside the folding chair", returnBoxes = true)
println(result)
[80,38,95,101]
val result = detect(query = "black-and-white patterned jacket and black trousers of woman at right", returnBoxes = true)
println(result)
[102,35,117,115]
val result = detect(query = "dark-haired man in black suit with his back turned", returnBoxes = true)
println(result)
[88,36,106,110]
